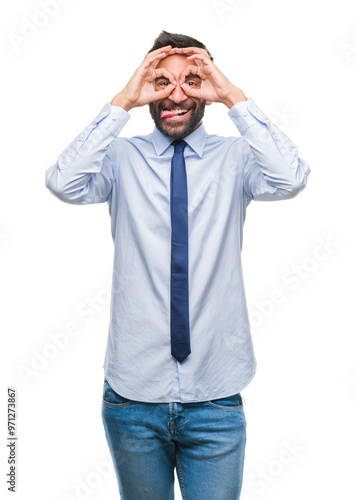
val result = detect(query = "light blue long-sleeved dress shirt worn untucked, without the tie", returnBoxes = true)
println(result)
[46,98,310,403]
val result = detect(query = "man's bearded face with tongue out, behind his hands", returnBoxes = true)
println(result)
[149,54,206,139]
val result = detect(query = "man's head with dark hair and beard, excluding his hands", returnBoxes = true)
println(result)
[148,31,213,139]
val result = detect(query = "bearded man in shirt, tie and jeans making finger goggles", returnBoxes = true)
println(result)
[46,31,310,500]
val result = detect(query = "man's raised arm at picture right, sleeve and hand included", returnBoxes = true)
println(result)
[176,47,310,200]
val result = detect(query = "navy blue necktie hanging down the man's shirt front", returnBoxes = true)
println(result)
[171,140,190,363]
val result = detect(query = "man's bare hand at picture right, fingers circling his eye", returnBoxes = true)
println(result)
[175,47,247,108]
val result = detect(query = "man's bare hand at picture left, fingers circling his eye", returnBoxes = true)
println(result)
[111,45,177,111]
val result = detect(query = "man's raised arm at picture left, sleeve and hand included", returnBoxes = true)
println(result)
[45,46,175,205]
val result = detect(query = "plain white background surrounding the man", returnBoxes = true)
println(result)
[0,0,356,500]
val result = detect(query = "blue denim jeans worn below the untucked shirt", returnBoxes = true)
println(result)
[102,379,246,500]
